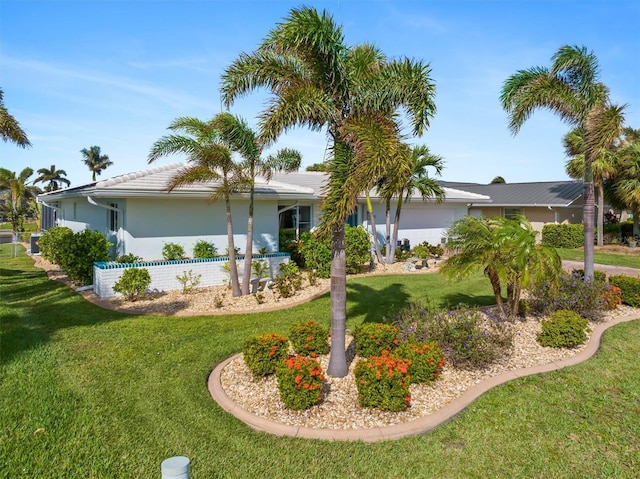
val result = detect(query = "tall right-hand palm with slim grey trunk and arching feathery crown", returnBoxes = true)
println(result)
[500,45,619,280]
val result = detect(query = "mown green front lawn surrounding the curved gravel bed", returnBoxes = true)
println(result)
[0,247,640,479]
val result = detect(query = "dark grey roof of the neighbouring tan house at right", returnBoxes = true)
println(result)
[440,181,584,207]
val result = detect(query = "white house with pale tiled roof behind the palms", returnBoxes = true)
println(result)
[38,164,491,260]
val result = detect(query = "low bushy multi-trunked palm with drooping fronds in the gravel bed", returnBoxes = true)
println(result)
[440,216,562,318]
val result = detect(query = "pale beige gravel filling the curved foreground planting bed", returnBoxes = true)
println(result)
[220,306,634,430]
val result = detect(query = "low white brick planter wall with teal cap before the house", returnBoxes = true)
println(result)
[93,253,291,298]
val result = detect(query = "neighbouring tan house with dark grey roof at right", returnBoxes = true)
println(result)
[441,181,584,231]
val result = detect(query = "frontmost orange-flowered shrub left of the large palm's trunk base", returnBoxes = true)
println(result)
[276,356,324,410]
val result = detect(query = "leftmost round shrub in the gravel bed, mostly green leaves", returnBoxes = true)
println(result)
[242,333,289,377]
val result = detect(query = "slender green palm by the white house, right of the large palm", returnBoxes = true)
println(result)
[382,145,445,263]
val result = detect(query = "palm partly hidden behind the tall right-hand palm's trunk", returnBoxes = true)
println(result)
[562,112,622,246]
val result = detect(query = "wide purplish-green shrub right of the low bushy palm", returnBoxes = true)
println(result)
[527,271,610,321]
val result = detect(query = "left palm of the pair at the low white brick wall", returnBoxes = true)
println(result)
[147,117,246,296]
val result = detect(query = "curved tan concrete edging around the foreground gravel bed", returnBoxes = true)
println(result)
[207,313,640,442]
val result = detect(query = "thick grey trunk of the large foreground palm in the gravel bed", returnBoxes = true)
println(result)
[327,224,349,378]
